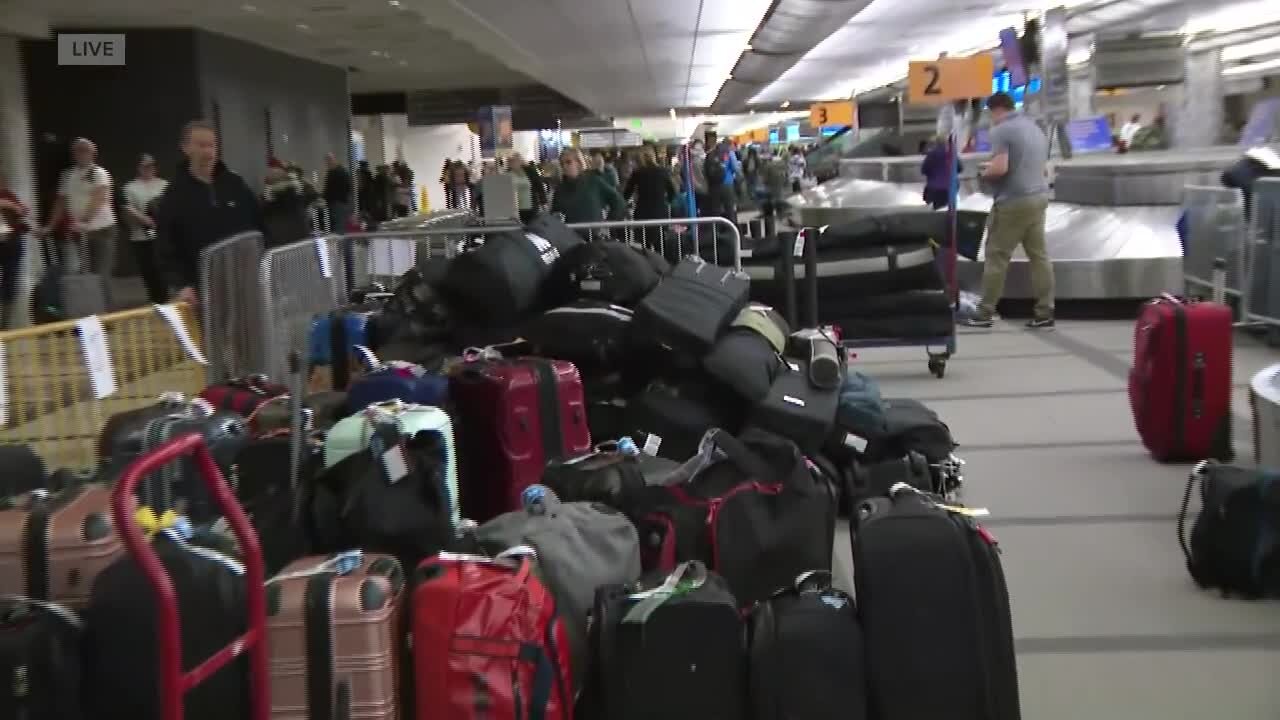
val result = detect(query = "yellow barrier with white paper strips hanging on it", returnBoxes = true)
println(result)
[0,305,205,470]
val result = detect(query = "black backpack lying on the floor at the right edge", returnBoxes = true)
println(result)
[1178,461,1280,598]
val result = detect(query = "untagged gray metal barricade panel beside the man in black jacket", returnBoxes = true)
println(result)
[200,232,266,383]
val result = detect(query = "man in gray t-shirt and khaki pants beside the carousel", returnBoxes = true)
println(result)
[964,92,1053,329]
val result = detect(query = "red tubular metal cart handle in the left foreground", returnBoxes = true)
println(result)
[111,433,271,720]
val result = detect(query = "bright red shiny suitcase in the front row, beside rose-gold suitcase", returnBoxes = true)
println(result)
[411,548,573,720]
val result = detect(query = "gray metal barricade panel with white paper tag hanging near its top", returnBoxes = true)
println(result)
[257,234,348,378]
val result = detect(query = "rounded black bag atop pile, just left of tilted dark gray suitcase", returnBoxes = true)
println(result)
[545,241,662,307]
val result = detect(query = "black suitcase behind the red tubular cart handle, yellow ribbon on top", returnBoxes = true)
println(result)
[83,530,250,720]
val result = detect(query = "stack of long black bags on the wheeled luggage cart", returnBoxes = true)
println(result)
[744,209,987,341]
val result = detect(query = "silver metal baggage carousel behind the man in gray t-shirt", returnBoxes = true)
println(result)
[790,147,1239,301]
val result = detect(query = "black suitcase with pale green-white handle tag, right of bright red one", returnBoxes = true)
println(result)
[580,562,748,720]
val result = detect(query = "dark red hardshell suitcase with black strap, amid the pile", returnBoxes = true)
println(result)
[449,357,591,523]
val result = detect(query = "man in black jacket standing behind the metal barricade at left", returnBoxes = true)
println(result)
[155,120,262,304]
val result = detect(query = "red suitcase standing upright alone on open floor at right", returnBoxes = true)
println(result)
[1129,295,1233,462]
